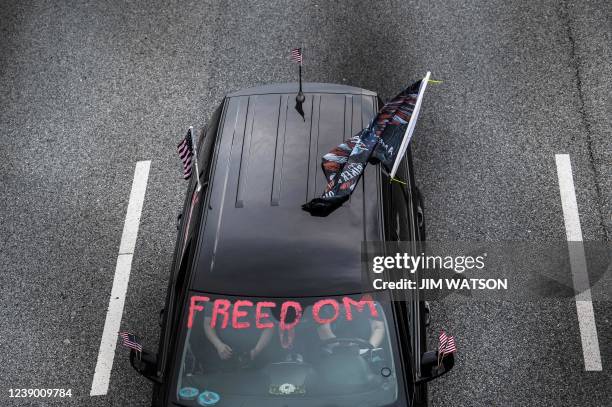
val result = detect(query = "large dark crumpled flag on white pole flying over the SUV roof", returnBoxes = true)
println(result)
[302,76,428,216]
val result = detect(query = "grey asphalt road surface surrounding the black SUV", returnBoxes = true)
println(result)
[0,0,612,406]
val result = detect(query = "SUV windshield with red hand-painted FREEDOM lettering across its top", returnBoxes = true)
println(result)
[175,294,401,407]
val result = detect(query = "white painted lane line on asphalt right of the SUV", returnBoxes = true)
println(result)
[555,154,602,371]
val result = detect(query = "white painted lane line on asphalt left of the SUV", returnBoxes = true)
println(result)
[89,161,151,396]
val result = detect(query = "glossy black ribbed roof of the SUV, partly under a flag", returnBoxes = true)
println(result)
[191,83,382,297]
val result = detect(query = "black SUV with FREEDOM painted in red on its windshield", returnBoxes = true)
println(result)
[130,83,454,407]
